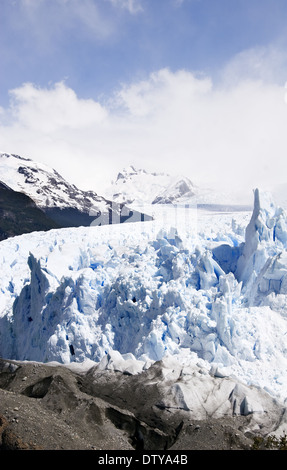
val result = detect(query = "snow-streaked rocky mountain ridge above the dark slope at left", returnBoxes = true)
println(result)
[0,153,148,232]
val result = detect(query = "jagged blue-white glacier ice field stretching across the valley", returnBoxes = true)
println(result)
[0,193,287,408]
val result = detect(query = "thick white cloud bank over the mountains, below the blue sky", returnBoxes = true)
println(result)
[0,60,287,198]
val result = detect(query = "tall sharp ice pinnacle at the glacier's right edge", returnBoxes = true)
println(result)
[235,189,287,305]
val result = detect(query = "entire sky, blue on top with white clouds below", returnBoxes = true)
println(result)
[0,0,287,200]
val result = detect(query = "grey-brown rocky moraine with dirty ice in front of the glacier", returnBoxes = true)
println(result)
[0,356,286,451]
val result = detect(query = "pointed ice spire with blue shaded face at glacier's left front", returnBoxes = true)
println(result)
[1,253,71,362]
